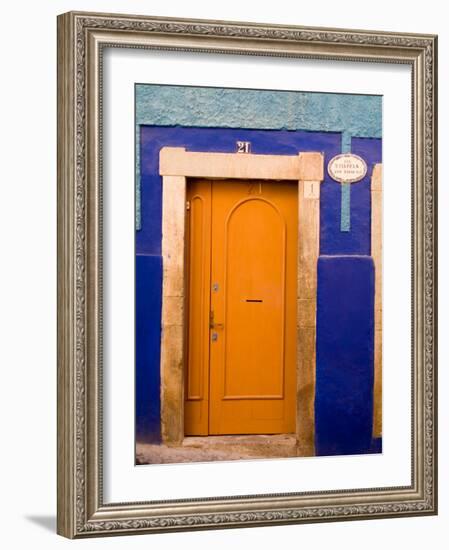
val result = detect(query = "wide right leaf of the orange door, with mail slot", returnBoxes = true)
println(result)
[209,180,297,434]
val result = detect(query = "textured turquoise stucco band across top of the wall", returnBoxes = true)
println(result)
[136,84,382,137]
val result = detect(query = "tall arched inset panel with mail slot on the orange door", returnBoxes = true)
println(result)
[223,197,286,400]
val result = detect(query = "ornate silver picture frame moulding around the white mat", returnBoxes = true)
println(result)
[57,12,437,538]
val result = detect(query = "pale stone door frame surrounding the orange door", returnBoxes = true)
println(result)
[159,147,324,456]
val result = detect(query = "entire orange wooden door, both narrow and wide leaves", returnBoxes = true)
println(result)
[185,180,297,435]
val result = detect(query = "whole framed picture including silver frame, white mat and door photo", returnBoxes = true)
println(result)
[58,12,437,538]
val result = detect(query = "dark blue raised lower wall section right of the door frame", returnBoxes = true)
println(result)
[315,256,374,455]
